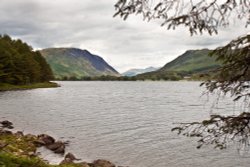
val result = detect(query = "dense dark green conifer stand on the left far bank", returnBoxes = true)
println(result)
[0,35,53,85]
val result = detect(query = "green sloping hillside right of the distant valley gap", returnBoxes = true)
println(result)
[137,49,220,80]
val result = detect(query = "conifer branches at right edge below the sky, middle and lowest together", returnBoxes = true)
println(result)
[172,35,250,149]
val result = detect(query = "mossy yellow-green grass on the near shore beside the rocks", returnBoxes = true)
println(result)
[0,134,87,167]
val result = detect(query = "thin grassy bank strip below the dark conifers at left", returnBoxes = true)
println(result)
[0,82,59,91]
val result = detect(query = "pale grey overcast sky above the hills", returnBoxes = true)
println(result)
[0,0,249,72]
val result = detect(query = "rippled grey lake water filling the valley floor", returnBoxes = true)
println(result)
[0,82,250,167]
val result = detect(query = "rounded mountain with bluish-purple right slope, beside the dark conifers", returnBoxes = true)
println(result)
[40,48,120,79]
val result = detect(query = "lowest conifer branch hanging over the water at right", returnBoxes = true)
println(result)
[172,112,250,149]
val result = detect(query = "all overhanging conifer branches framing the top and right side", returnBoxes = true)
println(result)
[114,0,250,149]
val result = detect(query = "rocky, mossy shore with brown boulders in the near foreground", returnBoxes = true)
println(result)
[0,120,127,167]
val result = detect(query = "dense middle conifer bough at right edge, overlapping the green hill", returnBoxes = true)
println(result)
[202,35,250,101]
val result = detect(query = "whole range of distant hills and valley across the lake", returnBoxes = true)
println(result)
[40,48,220,81]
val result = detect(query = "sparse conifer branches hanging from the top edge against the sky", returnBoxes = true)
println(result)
[114,0,250,35]
